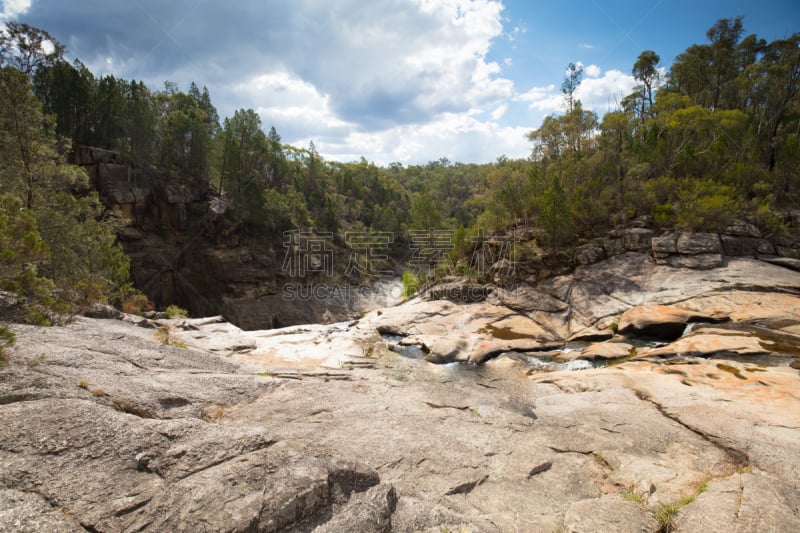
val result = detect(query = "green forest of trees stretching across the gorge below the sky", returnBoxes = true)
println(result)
[0,18,800,321]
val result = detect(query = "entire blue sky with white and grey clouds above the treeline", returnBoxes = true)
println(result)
[0,0,800,164]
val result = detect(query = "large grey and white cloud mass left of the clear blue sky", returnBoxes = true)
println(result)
[10,0,623,163]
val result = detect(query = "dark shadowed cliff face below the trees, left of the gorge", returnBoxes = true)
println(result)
[76,147,395,329]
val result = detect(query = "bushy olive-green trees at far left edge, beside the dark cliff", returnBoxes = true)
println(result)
[0,58,129,324]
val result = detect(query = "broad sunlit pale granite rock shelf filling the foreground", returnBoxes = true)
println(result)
[0,253,800,532]
